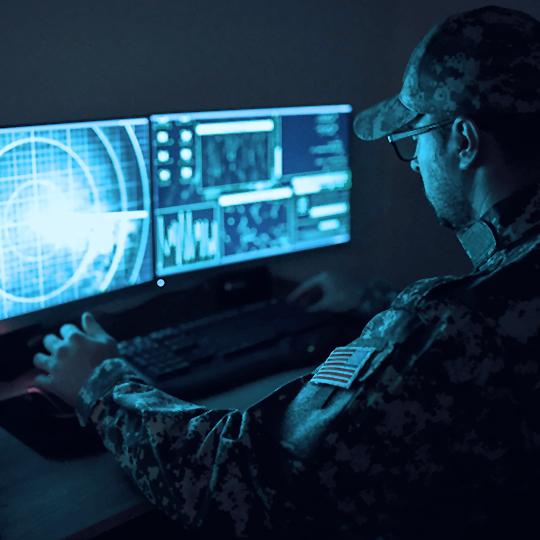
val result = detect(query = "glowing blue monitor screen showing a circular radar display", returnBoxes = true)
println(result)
[0,118,153,319]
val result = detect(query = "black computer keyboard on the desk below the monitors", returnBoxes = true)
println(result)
[119,300,362,398]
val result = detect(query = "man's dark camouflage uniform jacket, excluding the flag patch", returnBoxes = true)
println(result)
[78,184,540,540]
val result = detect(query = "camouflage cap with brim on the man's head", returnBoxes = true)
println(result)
[354,6,540,140]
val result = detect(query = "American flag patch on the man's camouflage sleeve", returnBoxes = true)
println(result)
[311,347,377,388]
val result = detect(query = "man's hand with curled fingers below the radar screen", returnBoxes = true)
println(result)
[34,312,118,406]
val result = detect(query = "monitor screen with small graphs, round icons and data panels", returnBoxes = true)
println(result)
[150,105,351,277]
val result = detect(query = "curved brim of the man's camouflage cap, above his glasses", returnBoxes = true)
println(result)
[354,96,419,141]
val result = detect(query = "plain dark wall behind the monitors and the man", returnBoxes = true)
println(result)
[0,0,540,294]
